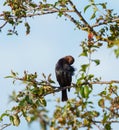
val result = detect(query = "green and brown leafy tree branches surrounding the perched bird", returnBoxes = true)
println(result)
[0,0,119,130]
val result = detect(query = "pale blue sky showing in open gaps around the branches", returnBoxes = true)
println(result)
[0,0,119,130]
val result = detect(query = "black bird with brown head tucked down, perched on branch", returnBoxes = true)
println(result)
[55,55,75,101]
